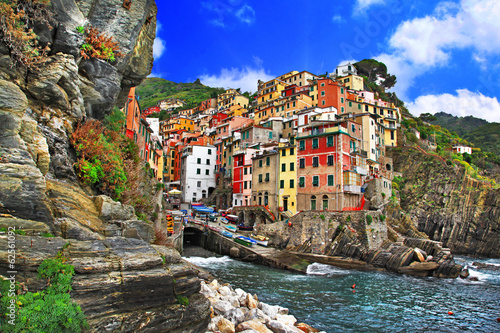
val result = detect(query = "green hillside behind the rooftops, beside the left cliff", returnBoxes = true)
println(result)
[136,78,224,109]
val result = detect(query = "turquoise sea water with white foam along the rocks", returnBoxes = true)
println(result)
[186,253,500,332]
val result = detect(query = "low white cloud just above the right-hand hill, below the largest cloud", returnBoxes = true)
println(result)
[407,89,500,122]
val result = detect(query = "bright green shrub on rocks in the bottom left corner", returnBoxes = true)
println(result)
[0,255,88,333]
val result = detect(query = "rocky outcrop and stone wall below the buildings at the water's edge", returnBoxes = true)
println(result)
[257,211,462,278]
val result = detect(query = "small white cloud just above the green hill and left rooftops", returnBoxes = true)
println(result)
[200,66,274,92]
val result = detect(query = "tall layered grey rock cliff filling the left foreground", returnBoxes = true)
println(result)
[0,0,210,332]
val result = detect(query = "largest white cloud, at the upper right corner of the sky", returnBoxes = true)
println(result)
[374,0,500,97]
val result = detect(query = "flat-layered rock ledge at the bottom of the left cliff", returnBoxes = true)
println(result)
[0,236,210,333]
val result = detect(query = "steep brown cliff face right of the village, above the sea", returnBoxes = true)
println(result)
[392,147,500,258]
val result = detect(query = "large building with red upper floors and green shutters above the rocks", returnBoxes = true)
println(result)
[297,116,366,211]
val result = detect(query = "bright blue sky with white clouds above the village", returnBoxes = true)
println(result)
[150,0,500,122]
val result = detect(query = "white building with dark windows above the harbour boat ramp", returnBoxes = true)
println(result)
[180,145,217,202]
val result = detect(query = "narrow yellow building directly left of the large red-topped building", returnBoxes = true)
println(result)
[278,143,297,220]
